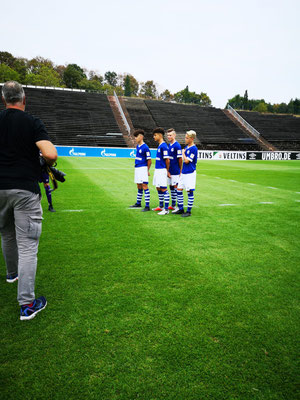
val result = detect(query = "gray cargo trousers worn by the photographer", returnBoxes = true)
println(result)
[0,189,43,305]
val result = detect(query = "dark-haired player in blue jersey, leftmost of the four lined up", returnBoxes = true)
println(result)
[130,129,152,211]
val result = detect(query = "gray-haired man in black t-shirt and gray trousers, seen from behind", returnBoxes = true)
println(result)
[0,81,57,320]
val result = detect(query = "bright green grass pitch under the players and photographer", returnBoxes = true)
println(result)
[0,158,300,400]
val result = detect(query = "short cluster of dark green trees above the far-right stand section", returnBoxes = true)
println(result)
[228,90,300,114]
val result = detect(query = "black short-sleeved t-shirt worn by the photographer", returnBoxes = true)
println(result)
[0,108,50,193]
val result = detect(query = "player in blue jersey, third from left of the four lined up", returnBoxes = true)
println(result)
[167,128,182,211]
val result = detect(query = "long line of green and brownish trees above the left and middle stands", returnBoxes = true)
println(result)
[0,51,211,106]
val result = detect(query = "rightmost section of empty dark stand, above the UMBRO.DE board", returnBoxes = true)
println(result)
[238,111,300,151]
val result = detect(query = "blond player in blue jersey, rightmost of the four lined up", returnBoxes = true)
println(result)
[173,131,198,217]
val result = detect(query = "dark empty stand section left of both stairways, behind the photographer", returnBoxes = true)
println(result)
[1,87,127,147]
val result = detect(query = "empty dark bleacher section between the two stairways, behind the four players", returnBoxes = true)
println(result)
[124,98,261,150]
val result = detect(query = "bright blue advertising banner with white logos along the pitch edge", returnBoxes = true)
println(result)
[55,146,156,158]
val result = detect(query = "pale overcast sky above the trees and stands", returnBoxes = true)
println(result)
[0,0,300,108]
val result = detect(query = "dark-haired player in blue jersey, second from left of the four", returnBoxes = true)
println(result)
[152,128,170,215]
